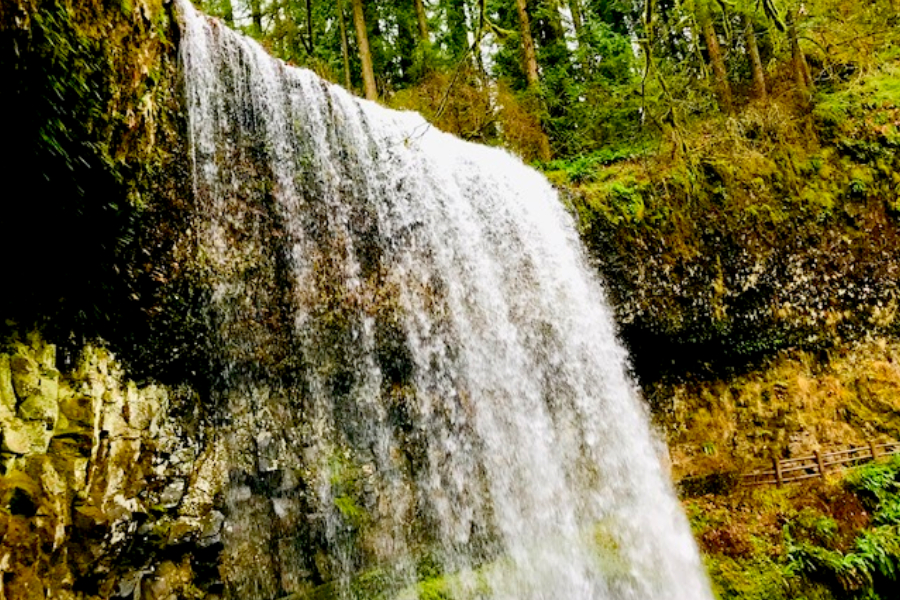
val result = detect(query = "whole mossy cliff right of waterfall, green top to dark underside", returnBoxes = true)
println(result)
[549,63,900,383]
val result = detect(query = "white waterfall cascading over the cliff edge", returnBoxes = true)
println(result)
[179,0,711,600]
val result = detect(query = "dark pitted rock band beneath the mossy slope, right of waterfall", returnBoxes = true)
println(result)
[595,213,900,385]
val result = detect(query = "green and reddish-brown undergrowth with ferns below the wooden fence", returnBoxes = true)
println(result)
[686,457,900,600]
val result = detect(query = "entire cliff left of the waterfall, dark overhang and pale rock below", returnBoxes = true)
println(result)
[0,0,229,600]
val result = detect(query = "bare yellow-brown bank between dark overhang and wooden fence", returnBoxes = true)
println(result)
[647,338,900,480]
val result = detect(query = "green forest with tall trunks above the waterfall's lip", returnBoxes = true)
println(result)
[196,0,900,161]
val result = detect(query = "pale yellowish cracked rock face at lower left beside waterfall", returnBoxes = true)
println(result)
[0,335,224,600]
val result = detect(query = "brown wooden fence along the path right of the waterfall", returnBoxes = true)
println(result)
[741,442,900,485]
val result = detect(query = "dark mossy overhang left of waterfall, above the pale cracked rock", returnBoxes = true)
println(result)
[0,0,214,380]
